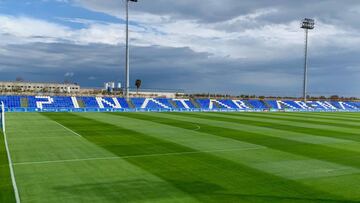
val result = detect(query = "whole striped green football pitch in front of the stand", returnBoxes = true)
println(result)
[0,112,360,203]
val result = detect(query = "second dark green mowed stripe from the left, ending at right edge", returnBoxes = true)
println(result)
[129,113,360,169]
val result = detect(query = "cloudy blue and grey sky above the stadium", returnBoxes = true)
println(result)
[0,0,360,97]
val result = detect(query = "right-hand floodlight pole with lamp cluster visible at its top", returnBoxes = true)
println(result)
[301,18,315,102]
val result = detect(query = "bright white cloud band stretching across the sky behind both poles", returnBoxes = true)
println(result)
[0,8,360,61]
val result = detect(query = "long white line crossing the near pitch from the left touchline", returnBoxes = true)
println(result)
[13,147,266,166]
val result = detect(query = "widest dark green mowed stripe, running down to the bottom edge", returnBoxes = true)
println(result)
[45,114,348,202]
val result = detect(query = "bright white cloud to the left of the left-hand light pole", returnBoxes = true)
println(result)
[0,15,124,45]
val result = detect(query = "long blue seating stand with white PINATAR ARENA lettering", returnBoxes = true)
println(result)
[0,96,360,111]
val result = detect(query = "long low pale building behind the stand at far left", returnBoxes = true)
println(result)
[0,82,80,93]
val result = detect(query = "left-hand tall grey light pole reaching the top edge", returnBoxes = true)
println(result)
[125,0,138,100]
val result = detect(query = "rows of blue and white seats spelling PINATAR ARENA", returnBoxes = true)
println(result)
[0,96,360,110]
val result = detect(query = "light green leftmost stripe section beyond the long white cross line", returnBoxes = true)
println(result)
[7,113,115,164]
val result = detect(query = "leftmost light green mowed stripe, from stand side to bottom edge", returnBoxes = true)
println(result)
[7,113,200,203]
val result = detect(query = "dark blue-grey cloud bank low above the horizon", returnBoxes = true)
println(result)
[0,43,360,96]
